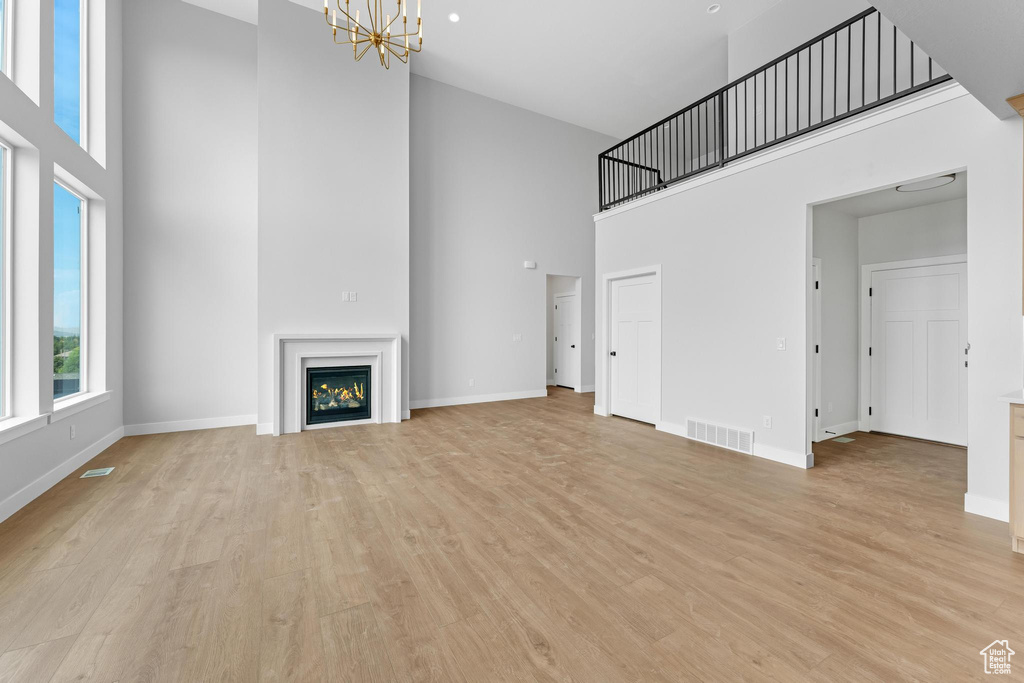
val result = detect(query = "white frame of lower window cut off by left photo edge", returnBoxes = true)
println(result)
[0,137,14,422]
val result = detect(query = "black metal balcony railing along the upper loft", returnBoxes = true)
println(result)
[598,9,951,211]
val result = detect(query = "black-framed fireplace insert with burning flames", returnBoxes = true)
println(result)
[306,366,371,425]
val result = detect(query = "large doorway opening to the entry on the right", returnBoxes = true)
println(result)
[808,171,970,451]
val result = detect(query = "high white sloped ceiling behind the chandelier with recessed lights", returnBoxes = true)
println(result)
[180,0,779,138]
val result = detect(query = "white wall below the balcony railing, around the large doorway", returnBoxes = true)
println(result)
[597,85,1024,518]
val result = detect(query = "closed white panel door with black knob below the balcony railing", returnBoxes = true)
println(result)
[608,275,660,423]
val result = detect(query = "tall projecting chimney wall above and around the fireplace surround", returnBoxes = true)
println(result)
[257,0,407,431]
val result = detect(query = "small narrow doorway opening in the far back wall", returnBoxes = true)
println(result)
[546,275,583,392]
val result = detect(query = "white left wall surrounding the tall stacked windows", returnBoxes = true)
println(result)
[0,0,123,520]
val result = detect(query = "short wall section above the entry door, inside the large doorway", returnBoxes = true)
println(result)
[858,199,968,264]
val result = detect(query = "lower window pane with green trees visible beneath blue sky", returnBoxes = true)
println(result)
[53,182,87,400]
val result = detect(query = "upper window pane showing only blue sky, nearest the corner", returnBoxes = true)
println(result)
[53,0,86,146]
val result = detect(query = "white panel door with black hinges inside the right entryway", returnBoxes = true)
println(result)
[870,263,968,445]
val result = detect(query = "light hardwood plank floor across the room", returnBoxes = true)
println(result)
[0,389,1024,683]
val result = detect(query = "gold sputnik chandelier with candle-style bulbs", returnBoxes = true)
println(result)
[324,0,423,69]
